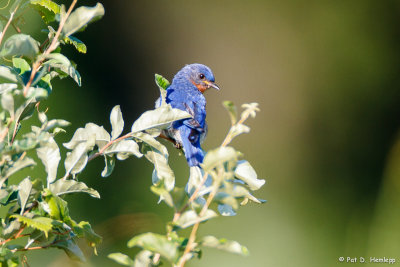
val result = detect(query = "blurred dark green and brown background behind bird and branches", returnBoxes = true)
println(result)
[8,0,400,267]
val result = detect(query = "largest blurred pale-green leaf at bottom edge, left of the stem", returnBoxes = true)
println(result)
[128,233,178,263]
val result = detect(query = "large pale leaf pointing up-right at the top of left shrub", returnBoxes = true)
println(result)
[62,3,104,36]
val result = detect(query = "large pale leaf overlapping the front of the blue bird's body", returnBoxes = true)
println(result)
[131,105,192,133]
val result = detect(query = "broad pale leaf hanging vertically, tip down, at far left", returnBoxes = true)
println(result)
[36,136,61,186]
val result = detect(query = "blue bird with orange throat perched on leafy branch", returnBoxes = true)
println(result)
[156,64,219,167]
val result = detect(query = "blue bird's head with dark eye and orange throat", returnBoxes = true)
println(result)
[177,63,219,93]
